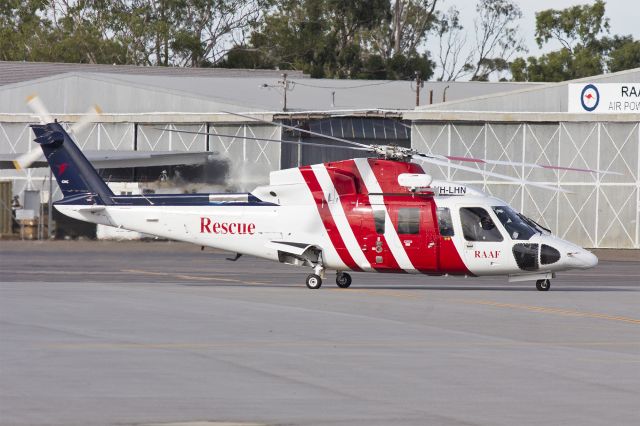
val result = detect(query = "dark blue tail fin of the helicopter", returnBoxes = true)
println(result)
[31,122,113,205]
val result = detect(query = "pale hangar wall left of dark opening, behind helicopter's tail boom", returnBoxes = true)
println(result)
[0,121,280,200]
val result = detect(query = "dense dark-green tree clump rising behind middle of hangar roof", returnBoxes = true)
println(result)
[221,0,434,79]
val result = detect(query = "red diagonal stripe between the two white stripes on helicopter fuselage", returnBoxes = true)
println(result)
[326,160,403,272]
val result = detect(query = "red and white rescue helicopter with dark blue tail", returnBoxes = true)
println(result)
[21,98,605,291]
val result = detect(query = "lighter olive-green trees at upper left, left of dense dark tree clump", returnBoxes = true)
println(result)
[0,0,271,66]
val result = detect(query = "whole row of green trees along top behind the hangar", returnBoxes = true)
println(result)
[0,0,640,81]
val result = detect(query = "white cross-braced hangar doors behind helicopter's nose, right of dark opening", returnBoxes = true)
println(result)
[412,120,640,248]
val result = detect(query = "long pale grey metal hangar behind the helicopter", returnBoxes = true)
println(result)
[0,62,640,248]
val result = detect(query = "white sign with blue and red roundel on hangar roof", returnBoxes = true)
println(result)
[569,83,640,114]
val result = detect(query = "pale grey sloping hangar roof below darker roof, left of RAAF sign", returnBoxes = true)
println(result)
[0,63,540,113]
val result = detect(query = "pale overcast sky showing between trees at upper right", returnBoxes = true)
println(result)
[428,0,640,79]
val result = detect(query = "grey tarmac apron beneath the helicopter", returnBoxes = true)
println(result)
[0,241,640,426]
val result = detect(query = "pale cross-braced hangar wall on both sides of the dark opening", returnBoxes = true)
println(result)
[0,112,640,248]
